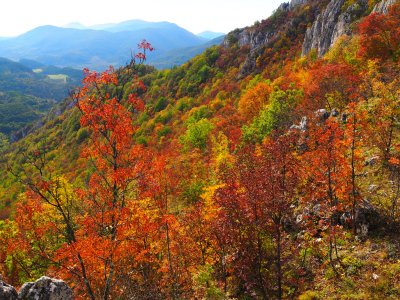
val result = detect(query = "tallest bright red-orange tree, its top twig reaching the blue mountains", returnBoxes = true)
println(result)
[69,41,152,299]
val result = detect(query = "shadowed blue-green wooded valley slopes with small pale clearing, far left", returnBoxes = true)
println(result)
[0,58,83,140]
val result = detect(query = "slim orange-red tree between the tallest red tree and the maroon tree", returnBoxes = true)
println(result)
[142,151,187,299]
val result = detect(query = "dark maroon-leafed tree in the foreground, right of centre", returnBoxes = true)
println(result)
[216,135,300,299]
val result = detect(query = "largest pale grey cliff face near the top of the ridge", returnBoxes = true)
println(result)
[303,0,368,56]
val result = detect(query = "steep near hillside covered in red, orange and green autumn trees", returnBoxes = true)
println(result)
[0,0,400,300]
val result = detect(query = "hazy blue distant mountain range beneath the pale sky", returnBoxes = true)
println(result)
[0,20,223,69]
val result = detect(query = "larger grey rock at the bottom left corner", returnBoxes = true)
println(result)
[17,276,73,300]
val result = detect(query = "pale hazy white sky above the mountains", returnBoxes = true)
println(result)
[0,0,289,36]
